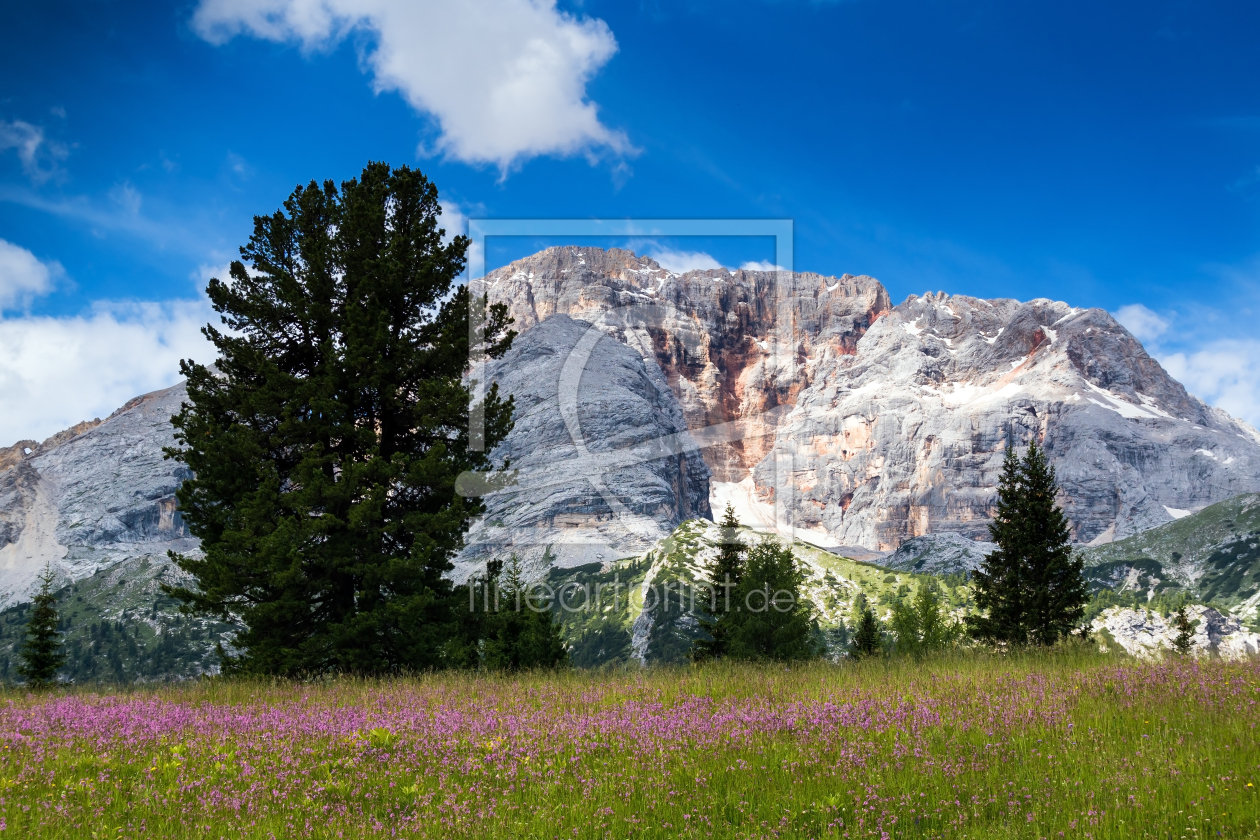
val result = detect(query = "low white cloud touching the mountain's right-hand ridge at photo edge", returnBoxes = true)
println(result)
[1158,339,1260,428]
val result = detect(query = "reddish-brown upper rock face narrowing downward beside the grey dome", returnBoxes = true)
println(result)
[484,247,890,482]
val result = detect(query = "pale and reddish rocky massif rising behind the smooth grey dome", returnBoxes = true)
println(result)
[478,247,1260,552]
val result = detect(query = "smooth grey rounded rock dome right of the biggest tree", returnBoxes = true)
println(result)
[455,315,711,579]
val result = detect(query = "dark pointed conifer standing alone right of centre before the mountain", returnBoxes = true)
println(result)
[966,441,1089,645]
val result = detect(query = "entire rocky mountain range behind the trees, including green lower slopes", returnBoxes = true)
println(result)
[0,248,1260,680]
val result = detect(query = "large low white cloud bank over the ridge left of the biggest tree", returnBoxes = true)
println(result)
[0,300,218,446]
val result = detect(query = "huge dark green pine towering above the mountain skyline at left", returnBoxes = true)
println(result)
[168,164,514,674]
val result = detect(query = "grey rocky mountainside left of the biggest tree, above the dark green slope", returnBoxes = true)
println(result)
[0,384,197,607]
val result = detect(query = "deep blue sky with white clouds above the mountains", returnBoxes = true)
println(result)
[0,0,1260,445]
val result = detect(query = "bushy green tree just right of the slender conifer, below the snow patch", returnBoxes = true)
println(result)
[718,536,822,661]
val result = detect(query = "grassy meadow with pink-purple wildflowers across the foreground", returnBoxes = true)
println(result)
[0,651,1260,839]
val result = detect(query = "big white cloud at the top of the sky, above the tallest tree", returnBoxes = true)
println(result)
[193,0,634,173]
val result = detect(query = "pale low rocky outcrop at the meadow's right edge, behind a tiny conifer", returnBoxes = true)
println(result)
[1090,604,1260,659]
